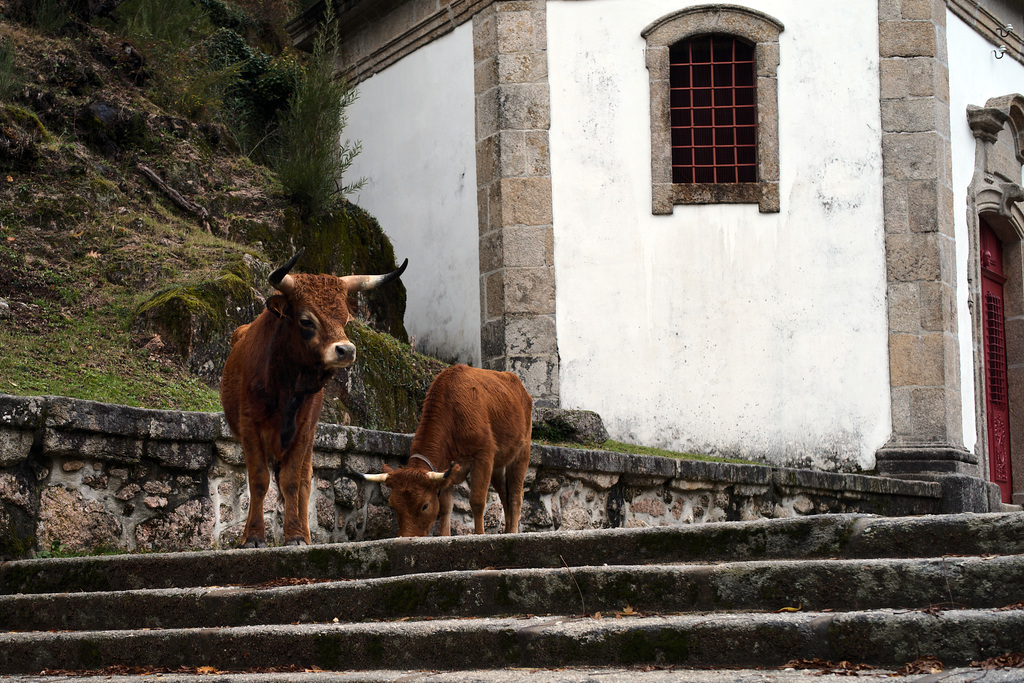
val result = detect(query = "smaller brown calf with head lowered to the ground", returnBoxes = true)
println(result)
[365,366,534,536]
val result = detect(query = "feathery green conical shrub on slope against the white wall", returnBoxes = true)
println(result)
[275,2,362,218]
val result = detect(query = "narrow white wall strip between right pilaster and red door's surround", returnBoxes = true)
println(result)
[946,11,1024,451]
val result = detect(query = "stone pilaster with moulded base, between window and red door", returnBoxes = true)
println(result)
[877,0,988,511]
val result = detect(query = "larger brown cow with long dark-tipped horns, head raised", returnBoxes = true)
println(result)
[220,251,409,548]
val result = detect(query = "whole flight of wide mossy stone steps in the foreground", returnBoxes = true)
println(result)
[0,513,1024,680]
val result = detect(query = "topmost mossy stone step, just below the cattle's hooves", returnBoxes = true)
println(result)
[8,512,1024,594]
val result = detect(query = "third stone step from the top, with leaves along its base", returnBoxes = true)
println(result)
[0,609,1024,674]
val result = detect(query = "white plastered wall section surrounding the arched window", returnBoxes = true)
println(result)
[547,0,891,470]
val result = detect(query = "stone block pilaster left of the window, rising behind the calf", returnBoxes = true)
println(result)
[473,0,558,407]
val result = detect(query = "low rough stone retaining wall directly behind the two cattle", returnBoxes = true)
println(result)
[0,394,941,557]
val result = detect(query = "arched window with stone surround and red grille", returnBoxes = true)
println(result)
[641,5,783,214]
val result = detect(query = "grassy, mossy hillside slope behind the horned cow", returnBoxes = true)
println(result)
[0,0,440,428]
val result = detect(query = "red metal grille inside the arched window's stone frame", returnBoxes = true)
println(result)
[669,34,758,183]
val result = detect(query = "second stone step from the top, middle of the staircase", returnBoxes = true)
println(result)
[0,555,1024,631]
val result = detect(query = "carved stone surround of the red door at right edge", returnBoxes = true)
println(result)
[967,94,1024,504]
